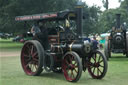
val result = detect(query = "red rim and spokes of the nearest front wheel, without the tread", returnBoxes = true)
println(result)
[62,54,79,81]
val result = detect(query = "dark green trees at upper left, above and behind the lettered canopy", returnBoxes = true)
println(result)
[0,0,78,32]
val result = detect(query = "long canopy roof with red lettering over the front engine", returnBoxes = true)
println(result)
[15,11,76,21]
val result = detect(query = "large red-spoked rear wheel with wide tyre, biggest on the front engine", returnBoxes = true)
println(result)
[21,40,44,76]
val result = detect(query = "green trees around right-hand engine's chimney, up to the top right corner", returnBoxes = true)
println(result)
[98,0,128,32]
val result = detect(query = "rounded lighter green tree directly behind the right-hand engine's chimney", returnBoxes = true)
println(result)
[99,8,128,32]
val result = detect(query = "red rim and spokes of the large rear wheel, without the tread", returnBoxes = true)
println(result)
[21,42,39,75]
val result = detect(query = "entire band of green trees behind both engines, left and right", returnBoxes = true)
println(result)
[0,0,128,34]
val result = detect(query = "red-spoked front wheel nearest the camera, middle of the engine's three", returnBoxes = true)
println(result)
[62,52,82,82]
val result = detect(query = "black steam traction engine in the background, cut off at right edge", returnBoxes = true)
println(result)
[105,14,128,59]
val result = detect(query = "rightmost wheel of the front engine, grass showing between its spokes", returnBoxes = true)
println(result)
[88,51,108,79]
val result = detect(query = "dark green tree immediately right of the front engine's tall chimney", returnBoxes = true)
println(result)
[84,5,101,35]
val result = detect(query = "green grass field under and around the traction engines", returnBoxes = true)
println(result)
[0,40,128,85]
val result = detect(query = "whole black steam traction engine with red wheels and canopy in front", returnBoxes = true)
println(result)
[15,6,107,82]
